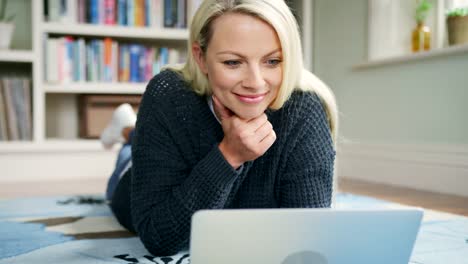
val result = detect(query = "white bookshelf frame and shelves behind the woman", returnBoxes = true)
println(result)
[0,0,188,148]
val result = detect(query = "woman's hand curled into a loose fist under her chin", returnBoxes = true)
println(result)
[213,95,276,169]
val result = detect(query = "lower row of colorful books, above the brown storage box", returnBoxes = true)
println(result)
[45,36,185,83]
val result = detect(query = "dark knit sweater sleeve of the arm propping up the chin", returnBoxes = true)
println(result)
[130,76,238,256]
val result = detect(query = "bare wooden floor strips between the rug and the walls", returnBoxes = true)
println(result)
[0,179,468,216]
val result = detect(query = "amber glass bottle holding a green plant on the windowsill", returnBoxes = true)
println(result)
[412,0,432,52]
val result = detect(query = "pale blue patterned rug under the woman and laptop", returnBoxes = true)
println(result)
[0,194,468,264]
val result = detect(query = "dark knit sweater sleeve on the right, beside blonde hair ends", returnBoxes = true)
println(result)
[280,95,335,208]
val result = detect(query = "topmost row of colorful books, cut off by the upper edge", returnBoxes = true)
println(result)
[45,0,202,28]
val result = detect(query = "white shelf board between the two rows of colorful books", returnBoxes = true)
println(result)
[42,22,188,41]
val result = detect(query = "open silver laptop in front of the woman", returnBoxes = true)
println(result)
[190,208,423,264]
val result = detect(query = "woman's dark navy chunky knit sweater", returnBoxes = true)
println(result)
[114,70,335,255]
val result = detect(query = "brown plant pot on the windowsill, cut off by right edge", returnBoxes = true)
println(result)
[446,7,468,45]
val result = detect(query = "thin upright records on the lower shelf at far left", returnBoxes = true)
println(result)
[0,77,32,141]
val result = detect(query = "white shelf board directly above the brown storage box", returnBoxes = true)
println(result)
[43,82,146,94]
